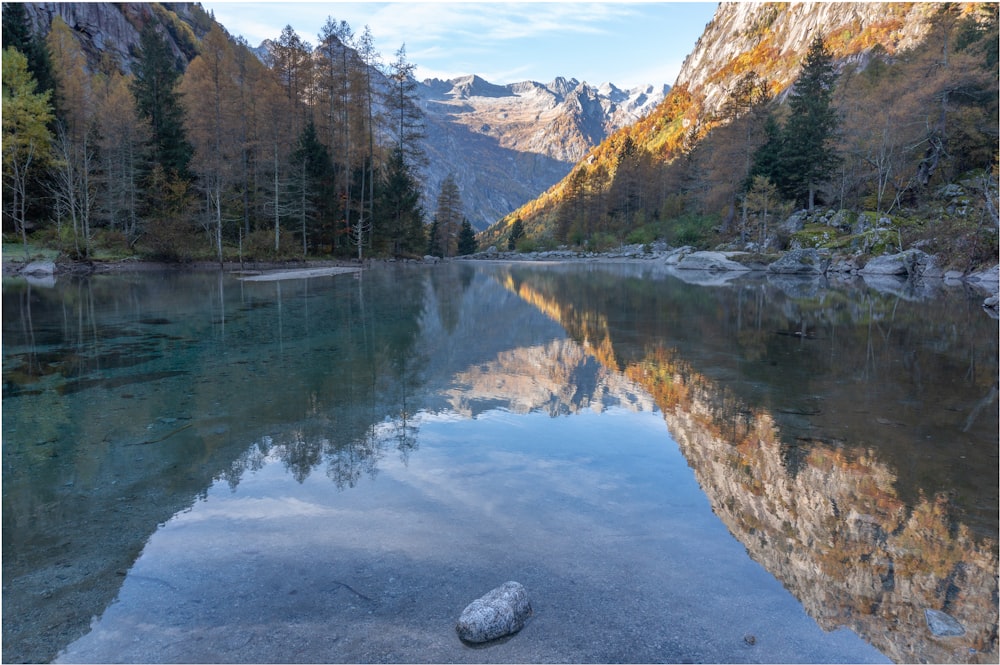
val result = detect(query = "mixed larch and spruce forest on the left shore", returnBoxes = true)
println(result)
[2,3,476,262]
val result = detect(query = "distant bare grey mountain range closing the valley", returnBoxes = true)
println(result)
[420,76,669,230]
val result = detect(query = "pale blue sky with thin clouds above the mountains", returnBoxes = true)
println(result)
[202,2,717,88]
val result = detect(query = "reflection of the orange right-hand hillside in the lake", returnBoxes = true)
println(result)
[506,262,998,662]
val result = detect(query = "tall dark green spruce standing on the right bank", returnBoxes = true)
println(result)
[781,35,840,210]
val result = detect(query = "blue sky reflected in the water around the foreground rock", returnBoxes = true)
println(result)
[63,408,878,662]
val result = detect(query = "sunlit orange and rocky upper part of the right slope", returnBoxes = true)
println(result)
[480,3,995,248]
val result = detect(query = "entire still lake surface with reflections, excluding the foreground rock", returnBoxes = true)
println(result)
[2,262,1000,662]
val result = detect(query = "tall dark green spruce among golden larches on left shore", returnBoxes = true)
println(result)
[132,22,193,179]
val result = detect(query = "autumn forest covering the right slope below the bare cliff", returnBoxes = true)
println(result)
[480,3,1000,270]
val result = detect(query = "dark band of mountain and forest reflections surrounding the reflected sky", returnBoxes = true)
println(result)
[3,265,998,662]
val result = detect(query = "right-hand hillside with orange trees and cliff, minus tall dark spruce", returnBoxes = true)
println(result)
[480,3,998,269]
